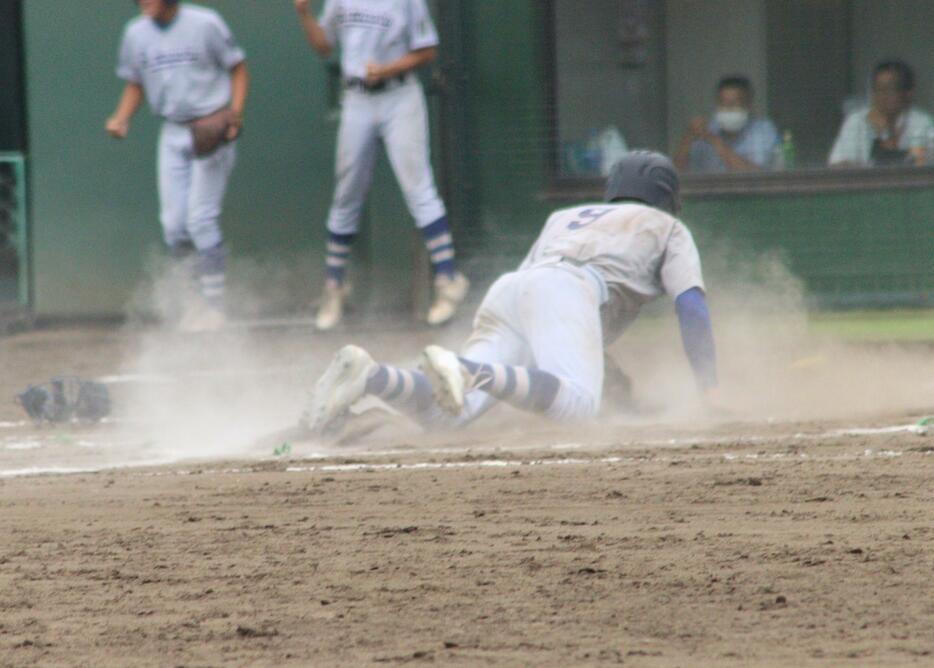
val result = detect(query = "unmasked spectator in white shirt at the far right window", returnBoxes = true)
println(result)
[828,60,934,167]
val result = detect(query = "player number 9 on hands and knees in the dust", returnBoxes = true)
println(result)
[304,151,717,433]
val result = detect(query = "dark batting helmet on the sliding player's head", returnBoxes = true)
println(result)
[605,151,681,214]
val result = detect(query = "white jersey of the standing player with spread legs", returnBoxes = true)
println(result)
[319,0,438,79]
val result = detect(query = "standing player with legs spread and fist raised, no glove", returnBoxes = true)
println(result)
[295,0,469,330]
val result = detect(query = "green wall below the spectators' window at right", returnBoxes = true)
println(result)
[684,189,934,307]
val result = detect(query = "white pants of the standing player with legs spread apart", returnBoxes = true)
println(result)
[327,76,446,235]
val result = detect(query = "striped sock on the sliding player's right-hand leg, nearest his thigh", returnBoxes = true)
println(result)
[458,357,561,413]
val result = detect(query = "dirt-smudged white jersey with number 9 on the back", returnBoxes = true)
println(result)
[520,203,704,343]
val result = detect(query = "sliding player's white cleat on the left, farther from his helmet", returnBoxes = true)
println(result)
[302,346,377,433]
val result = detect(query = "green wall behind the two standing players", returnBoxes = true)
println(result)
[24,0,424,316]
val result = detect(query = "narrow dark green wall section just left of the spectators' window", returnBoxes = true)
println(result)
[461,0,552,263]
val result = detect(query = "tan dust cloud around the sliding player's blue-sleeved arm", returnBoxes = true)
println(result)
[614,246,934,421]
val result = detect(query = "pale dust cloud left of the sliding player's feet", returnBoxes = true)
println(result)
[112,253,316,460]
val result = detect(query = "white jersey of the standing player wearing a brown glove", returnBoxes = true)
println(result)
[117,5,245,123]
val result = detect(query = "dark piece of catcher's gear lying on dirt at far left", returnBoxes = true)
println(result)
[16,378,110,423]
